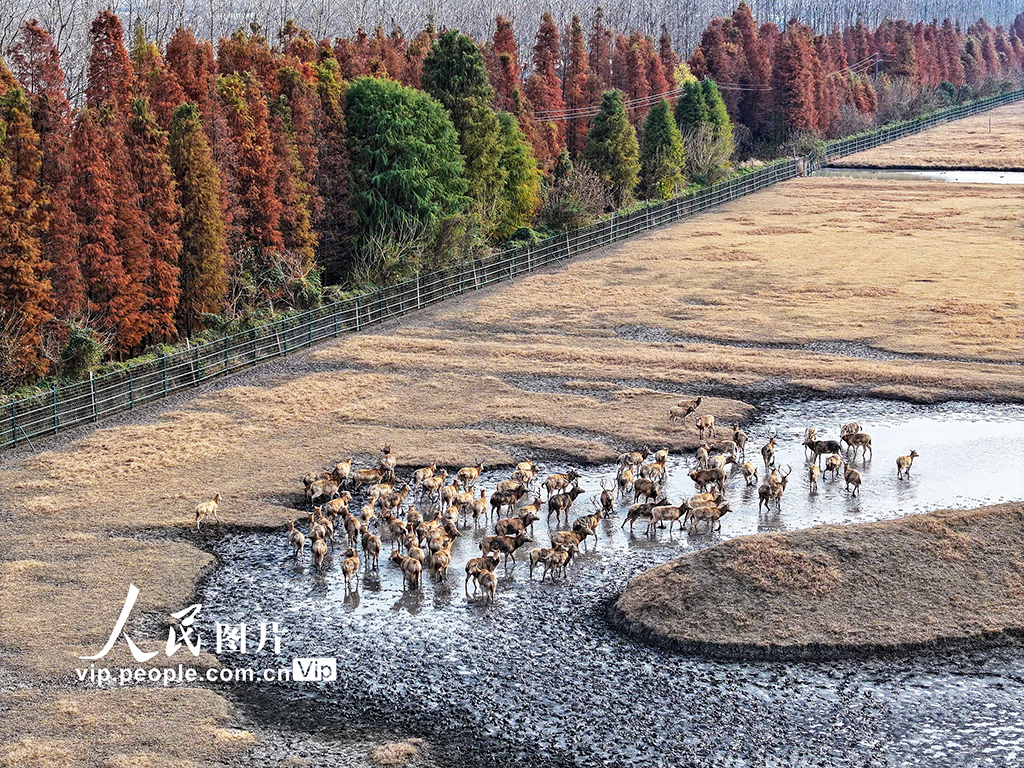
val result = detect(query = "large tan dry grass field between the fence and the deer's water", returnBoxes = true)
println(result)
[0,173,1024,768]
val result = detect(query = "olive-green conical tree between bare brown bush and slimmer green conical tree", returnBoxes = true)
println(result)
[582,90,640,208]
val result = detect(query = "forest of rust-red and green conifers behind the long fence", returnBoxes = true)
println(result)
[0,2,1024,391]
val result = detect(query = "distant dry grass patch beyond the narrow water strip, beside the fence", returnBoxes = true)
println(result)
[840,101,1024,170]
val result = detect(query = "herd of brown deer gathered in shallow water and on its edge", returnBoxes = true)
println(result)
[196,397,918,604]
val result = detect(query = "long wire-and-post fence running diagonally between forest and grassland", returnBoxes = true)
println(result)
[0,89,1024,449]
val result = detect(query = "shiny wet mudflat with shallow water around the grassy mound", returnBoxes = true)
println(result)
[201,400,1024,766]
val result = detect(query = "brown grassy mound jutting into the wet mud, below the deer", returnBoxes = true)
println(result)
[611,503,1024,657]
